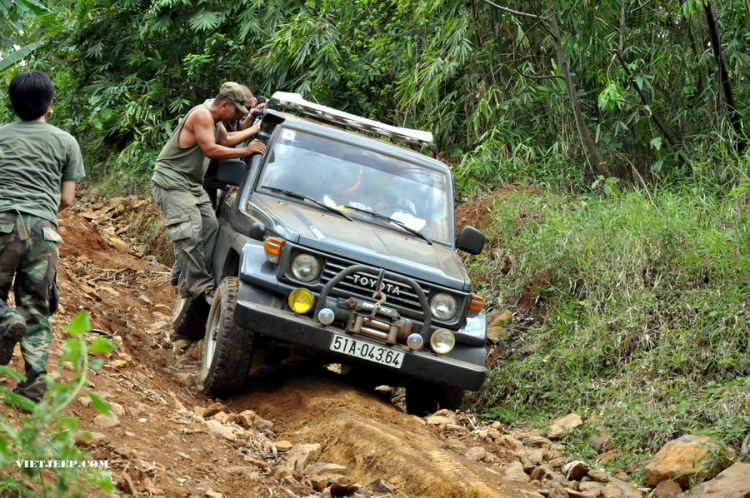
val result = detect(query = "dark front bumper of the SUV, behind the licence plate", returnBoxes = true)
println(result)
[234,300,487,391]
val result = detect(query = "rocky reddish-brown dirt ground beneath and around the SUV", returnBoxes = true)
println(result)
[0,198,750,498]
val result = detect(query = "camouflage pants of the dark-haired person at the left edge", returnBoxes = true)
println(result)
[0,212,62,379]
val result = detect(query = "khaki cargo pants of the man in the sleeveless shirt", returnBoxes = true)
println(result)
[151,185,219,297]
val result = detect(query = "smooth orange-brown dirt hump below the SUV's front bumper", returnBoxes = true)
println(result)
[230,370,521,498]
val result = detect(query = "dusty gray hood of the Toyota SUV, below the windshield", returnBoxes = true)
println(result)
[253,198,470,291]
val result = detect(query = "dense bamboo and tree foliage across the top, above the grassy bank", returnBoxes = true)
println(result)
[0,0,750,194]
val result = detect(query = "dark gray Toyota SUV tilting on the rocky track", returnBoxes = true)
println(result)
[174,93,494,415]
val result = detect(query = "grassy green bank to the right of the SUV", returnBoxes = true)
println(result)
[470,188,750,464]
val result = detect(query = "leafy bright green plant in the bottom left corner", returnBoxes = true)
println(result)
[0,314,115,497]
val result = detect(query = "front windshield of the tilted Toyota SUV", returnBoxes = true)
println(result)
[258,128,452,244]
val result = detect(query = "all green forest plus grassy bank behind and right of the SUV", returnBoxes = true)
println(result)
[0,0,750,469]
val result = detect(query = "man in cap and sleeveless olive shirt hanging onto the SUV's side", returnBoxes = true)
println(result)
[151,82,266,298]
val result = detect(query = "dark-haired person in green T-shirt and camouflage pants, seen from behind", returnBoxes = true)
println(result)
[0,71,84,401]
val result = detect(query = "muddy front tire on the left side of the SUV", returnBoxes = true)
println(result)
[200,277,254,396]
